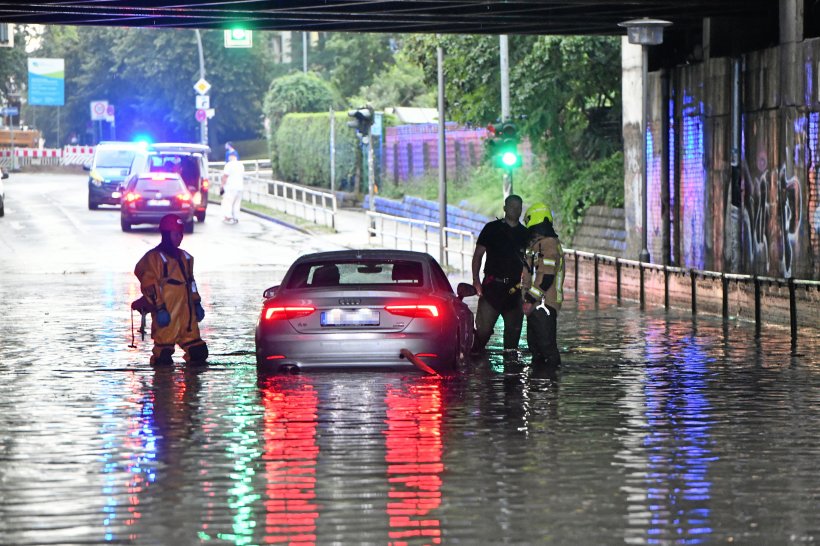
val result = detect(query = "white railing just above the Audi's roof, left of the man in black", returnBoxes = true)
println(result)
[366,211,475,271]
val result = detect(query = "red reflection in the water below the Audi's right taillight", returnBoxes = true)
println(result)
[384,381,444,546]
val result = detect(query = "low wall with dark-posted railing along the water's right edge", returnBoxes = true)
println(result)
[564,249,820,348]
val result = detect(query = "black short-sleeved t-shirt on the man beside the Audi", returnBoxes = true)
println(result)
[477,218,529,282]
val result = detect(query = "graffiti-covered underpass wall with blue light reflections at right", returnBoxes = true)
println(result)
[647,36,820,280]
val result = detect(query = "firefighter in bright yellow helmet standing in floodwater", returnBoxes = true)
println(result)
[521,203,564,366]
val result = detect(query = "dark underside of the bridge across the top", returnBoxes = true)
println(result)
[0,0,778,35]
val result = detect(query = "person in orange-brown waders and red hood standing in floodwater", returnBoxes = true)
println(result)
[134,214,208,366]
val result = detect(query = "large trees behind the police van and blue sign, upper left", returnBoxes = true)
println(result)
[21,26,273,144]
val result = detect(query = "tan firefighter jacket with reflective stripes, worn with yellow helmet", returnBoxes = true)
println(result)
[521,228,564,310]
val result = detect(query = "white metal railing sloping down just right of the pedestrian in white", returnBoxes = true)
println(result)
[211,170,338,229]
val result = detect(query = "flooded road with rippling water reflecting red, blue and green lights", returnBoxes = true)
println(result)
[0,174,820,545]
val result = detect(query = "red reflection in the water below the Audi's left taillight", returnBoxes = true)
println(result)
[262,377,319,544]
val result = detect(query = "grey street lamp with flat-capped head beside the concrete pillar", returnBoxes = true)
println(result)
[618,18,672,262]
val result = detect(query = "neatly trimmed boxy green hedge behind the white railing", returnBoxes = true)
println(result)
[274,112,358,188]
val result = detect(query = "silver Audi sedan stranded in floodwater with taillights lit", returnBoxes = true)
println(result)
[256,250,476,375]
